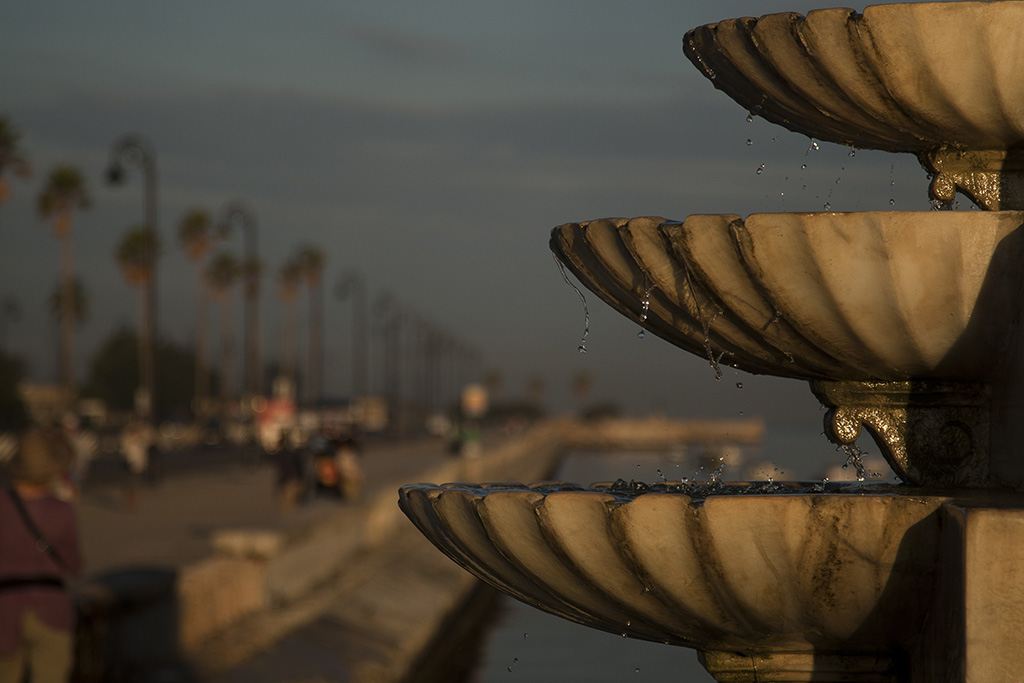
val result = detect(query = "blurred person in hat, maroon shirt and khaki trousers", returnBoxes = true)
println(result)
[0,427,82,683]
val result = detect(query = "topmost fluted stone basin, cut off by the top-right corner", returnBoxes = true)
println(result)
[684,1,1024,154]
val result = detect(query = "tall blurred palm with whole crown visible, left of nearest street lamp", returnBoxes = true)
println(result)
[37,165,92,395]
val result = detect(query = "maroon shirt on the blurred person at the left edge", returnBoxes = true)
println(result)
[0,489,82,656]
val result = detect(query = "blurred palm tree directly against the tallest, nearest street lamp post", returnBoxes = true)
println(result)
[114,226,160,420]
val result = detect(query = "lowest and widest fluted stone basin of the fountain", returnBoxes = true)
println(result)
[399,484,942,654]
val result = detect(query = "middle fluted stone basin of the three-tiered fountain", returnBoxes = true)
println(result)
[551,211,1024,381]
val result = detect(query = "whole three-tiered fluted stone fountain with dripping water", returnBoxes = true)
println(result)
[400,1,1024,683]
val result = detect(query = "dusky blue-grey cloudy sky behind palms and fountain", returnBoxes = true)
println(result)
[0,0,942,428]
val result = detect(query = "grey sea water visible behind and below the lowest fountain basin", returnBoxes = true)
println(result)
[467,423,864,683]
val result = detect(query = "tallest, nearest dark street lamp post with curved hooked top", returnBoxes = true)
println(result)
[106,134,159,422]
